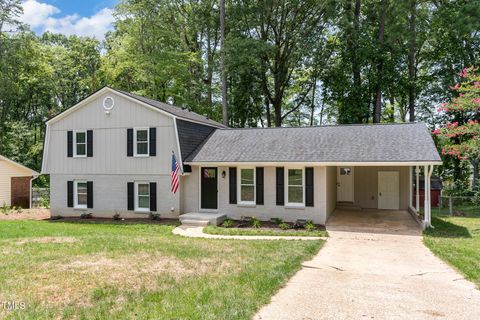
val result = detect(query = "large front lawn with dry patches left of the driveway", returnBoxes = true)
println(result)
[0,221,323,319]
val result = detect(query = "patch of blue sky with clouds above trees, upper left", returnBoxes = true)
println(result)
[20,0,118,40]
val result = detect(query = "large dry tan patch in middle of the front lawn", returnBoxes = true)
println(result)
[24,253,232,306]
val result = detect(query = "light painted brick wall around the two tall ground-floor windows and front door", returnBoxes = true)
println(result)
[181,167,327,224]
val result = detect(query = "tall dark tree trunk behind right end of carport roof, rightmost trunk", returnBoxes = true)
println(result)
[408,0,417,122]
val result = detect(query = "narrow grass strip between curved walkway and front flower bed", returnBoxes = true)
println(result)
[203,226,327,237]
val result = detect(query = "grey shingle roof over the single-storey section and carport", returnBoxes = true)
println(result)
[185,123,441,164]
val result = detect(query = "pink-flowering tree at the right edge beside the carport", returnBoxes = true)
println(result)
[433,67,480,189]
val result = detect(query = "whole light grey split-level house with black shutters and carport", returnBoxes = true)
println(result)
[42,88,441,228]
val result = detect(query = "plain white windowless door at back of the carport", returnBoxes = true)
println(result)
[378,171,400,210]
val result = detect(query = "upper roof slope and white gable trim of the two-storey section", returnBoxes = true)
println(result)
[47,87,227,128]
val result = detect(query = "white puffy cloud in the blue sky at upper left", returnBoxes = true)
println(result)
[21,0,114,40]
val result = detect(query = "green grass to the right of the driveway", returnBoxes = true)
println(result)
[424,209,480,288]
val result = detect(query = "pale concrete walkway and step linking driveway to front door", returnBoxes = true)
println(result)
[173,226,326,240]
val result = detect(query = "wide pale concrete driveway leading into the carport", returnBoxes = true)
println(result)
[254,210,480,320]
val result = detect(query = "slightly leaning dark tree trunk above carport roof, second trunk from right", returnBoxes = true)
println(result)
[373,0,387,123]
